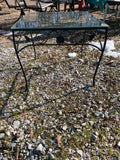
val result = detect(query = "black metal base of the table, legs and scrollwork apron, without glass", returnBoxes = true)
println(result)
[12,27,108,91]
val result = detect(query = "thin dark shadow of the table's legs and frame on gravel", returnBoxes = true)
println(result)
[0,64,91,119]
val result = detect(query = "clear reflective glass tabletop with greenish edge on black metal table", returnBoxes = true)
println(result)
[11,11,108,30]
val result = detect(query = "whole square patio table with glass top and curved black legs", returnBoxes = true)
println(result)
[11,11,109,90]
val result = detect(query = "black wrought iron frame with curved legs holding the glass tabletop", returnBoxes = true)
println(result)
[12,11,108,90]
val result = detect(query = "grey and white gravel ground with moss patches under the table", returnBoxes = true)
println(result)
[0,0,120,160]
